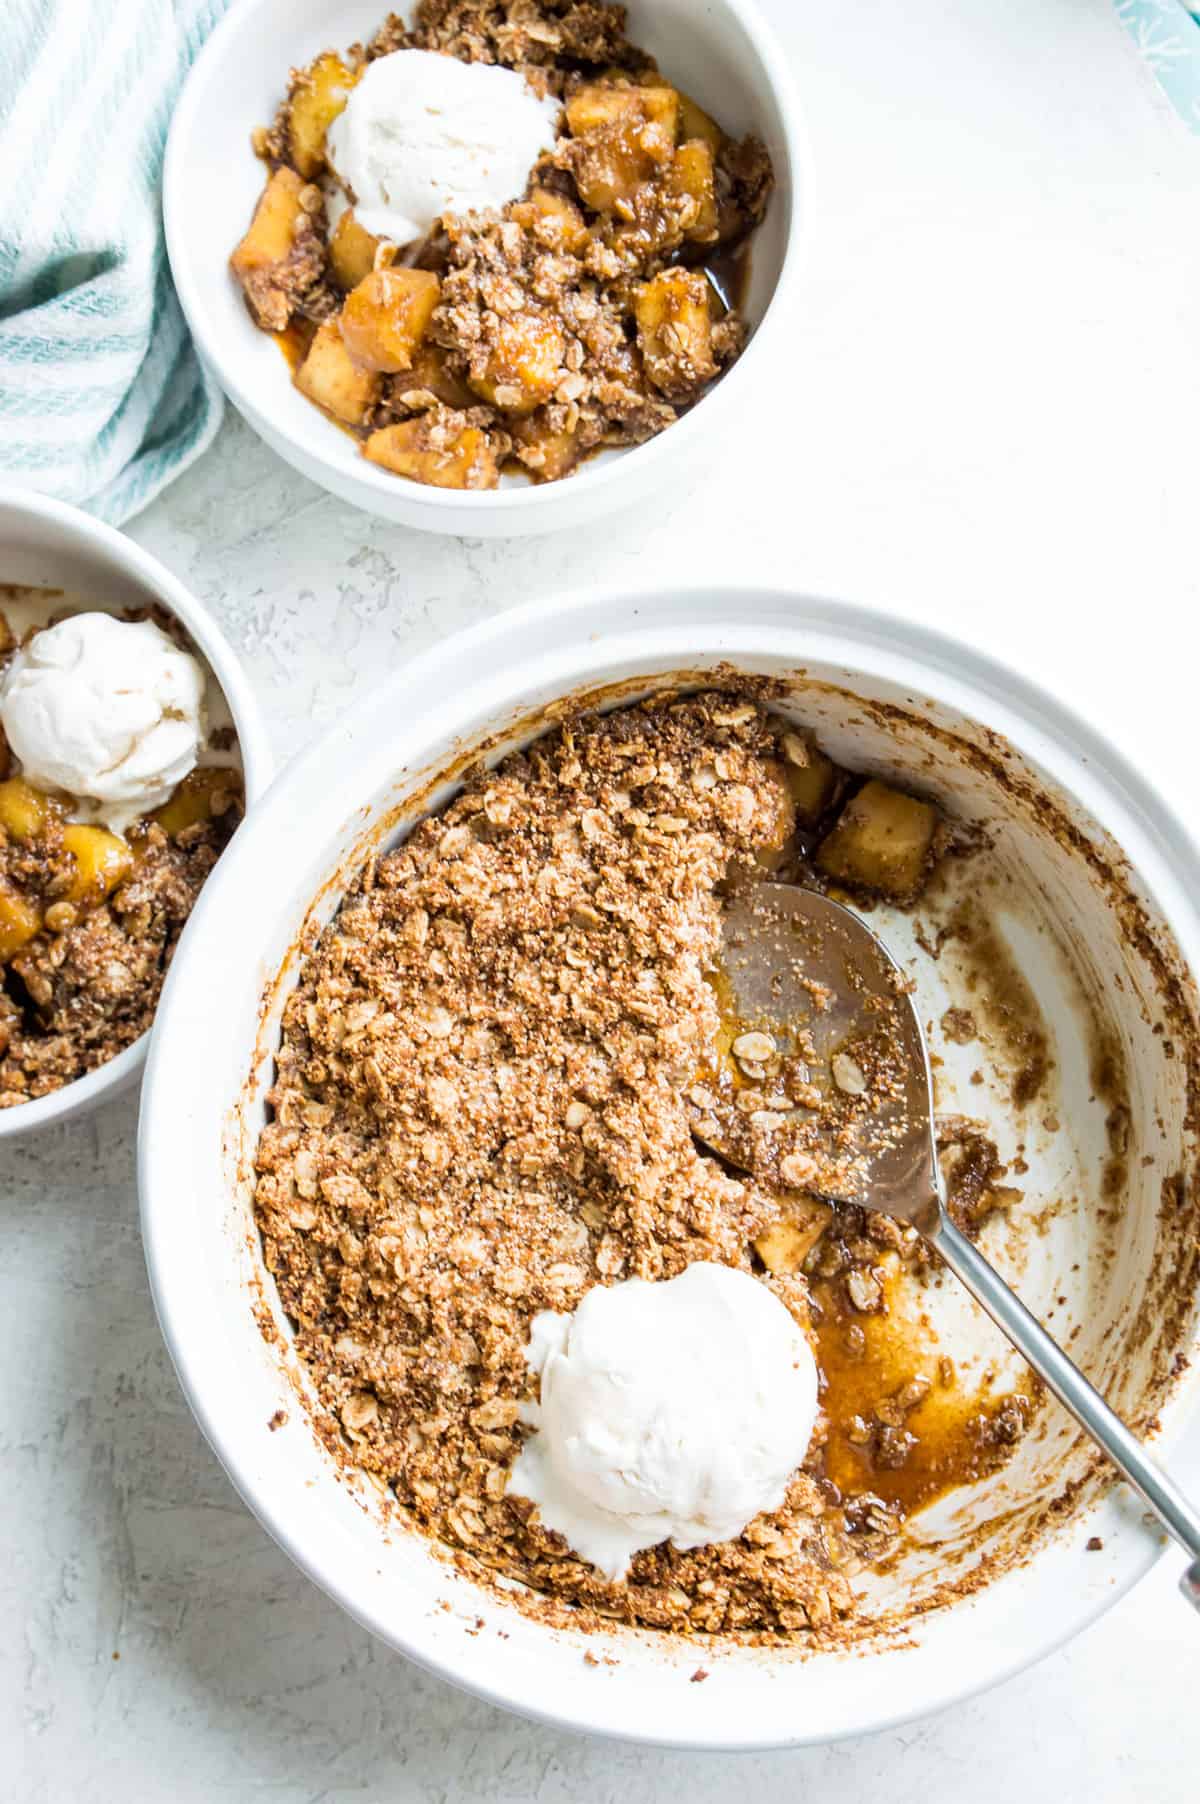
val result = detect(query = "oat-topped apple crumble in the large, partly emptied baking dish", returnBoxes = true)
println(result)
[256,693,1030,1634]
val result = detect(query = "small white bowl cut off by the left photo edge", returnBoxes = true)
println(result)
[0,485,271,1140]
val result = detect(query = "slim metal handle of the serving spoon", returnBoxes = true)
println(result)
[926,1210,1200,1609]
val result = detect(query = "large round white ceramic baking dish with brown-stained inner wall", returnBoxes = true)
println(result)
[139,590,1200,1750]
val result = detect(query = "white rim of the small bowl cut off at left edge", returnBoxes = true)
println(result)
[0,483,274,1142]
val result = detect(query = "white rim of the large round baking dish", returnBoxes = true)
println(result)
[137,584,1200,1752]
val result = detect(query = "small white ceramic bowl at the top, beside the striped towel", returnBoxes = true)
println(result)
[162,0,812,538]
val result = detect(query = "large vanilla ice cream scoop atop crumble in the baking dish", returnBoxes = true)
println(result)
[509,1263,817,1579]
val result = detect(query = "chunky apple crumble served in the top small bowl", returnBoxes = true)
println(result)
[231,0,772,489]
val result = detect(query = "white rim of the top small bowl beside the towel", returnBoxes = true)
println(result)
[162,0,804,532]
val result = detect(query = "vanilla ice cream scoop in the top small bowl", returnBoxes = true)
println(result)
[325,51,559,244]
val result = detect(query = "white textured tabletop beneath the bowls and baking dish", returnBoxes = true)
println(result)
[9,0,1200,1804]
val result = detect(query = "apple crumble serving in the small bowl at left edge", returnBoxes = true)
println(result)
[0,584,242,1108]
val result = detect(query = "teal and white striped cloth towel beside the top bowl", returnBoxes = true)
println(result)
[0,0,229,521]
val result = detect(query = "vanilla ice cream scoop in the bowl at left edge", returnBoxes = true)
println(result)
[0,613,204,833]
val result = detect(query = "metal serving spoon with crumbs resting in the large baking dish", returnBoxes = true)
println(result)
[697,882,1200,1609]
